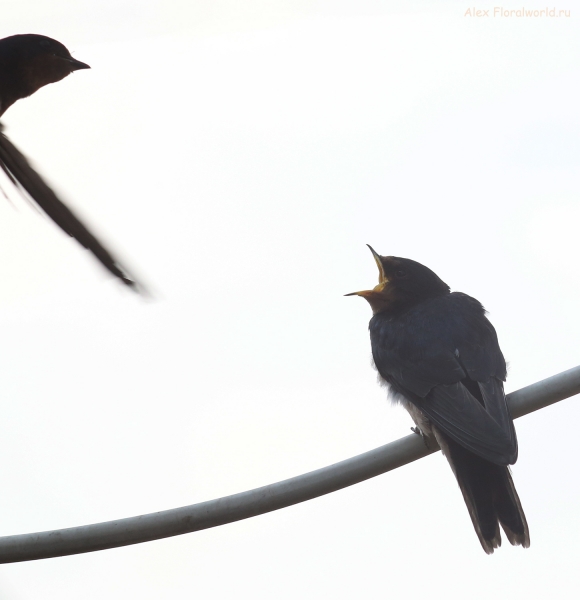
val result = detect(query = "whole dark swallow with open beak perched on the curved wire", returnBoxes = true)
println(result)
[347,246,530,554]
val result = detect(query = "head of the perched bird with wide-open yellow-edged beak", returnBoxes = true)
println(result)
[346,246,449,314]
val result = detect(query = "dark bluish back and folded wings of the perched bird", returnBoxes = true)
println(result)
[370,293,517,465]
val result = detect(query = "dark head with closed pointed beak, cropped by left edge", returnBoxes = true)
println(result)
[0,33,90,115]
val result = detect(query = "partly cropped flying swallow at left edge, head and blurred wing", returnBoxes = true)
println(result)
[0,34,142,290]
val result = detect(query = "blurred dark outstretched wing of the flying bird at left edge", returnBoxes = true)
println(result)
[0,125,140,291]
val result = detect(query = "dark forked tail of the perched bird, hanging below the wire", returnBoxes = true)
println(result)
[433,428,530,554]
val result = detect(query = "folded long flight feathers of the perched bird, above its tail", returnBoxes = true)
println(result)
[412,377,518,465]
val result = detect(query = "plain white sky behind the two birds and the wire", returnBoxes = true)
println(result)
[0,0,580,600]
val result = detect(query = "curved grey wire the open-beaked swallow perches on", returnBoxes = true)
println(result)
[0,366,580,563]
